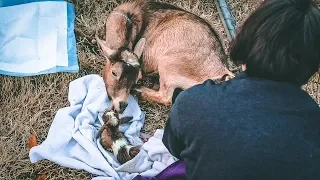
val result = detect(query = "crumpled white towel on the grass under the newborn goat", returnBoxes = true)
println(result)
[29,75,176,179]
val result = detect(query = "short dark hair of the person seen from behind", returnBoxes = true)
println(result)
[230,0,320,85]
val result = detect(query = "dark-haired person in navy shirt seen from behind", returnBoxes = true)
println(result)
[163,0,320,180]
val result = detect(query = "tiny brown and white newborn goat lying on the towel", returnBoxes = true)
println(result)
[98,110,140,164]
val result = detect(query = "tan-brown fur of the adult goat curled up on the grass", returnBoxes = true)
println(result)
[98,0,233,111]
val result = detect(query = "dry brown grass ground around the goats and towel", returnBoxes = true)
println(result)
[0,0,320,179]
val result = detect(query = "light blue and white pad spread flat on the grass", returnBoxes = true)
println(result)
[0,0,79,76]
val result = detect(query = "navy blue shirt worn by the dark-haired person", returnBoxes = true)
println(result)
[163,73,320,180]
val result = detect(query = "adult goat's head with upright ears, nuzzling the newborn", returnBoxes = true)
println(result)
[96,36,145,113]
